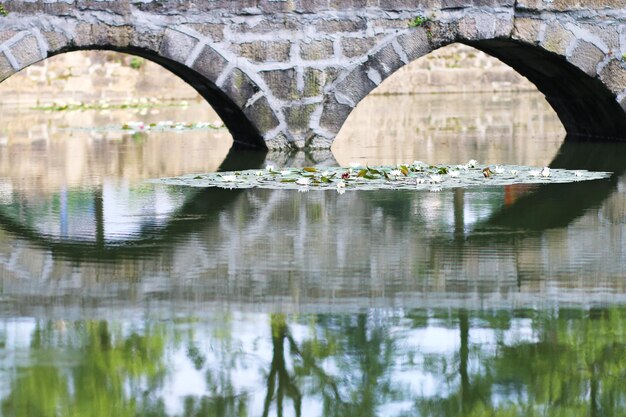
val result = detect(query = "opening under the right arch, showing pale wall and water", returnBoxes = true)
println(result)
[332,43,566,165]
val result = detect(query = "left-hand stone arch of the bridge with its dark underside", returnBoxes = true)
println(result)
[0,23,279,149]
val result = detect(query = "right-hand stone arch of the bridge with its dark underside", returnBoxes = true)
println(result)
[319,18,626,145]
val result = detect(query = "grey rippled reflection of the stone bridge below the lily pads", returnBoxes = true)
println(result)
[0,143,626,309]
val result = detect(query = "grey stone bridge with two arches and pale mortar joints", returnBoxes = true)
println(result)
[0,0,626,149]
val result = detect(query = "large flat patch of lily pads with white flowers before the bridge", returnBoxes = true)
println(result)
[156,160,610,194]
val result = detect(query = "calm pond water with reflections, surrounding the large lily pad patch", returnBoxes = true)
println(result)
[0,94,626,417]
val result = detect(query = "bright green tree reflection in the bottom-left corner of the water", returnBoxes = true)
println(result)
[2,321,167,417]
